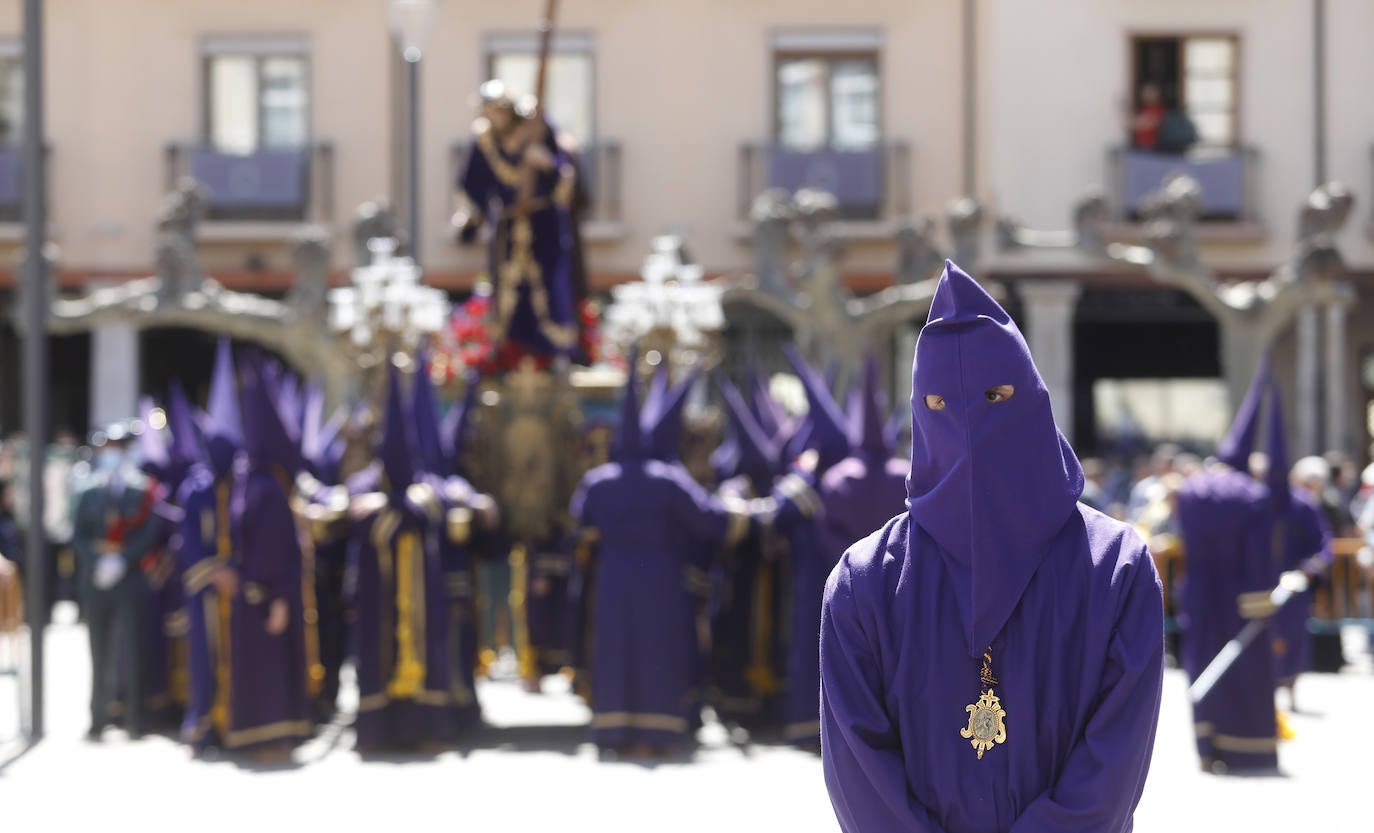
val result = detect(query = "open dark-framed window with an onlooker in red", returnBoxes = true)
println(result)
[1132,34,1239,148]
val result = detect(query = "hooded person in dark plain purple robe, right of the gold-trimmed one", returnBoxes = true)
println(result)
[224,368,313,749]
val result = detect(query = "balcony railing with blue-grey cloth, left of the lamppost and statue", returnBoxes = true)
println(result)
[165,142,334,223]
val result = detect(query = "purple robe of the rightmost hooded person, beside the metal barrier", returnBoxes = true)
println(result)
[1274,489,1331,686]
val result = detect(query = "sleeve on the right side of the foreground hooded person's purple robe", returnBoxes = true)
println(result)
[1011,550,1164,833]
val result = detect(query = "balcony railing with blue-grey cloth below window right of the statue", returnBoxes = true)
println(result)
[738,140,911,220]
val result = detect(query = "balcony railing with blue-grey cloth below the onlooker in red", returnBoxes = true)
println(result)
[1107,146,1260,224]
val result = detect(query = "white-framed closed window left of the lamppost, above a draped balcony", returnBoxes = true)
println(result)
[205,38,309,154]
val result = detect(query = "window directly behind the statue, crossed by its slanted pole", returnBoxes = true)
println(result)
[486,33,596,147]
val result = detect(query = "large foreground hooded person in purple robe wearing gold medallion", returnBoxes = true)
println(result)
[820,263,1164,833]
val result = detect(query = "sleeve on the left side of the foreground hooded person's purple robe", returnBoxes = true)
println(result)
[820,554,943,833]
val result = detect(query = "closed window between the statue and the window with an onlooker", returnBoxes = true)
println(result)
[774,52,881,150]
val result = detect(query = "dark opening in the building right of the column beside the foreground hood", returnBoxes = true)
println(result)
[1073,289,1221,455]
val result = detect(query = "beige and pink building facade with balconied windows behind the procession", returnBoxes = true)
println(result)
[0,0,1374,464]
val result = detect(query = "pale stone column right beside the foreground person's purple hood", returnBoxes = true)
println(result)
[1017,280,1083,441]
